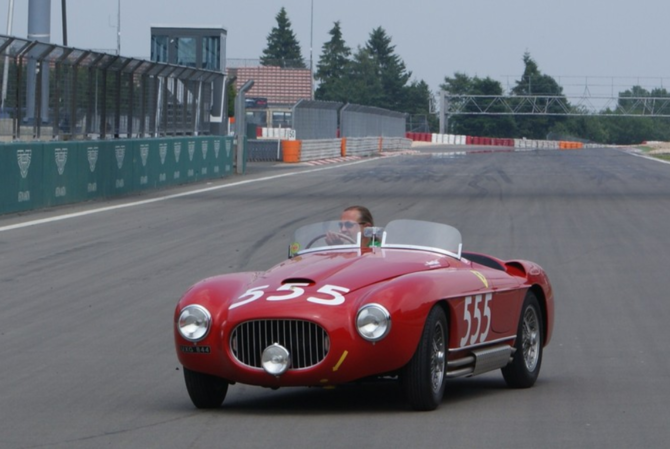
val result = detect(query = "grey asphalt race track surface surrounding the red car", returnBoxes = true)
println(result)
[0,146,670,449]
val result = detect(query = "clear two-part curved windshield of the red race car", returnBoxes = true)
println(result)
[289,220,462,258]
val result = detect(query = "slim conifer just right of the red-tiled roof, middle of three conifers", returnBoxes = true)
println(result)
[314,22,351,101]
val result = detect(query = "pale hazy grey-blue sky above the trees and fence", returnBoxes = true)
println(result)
[0,0,670,95]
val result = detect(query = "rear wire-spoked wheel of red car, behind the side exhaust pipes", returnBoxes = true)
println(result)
[501,291,543,388]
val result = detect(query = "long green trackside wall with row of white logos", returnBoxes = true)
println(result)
[0,136,234,214]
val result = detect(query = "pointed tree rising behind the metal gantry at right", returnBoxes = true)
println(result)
[512,52,567,139]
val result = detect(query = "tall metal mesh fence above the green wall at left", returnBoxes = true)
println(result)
[0,35,224,141]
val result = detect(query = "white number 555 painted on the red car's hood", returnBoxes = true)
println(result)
[228,282,349,310]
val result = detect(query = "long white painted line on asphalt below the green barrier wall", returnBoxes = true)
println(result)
[0,158,374,232]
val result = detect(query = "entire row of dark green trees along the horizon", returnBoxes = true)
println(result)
[261,8,670,144]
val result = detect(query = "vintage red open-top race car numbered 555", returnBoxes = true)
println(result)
[174,220,554,410]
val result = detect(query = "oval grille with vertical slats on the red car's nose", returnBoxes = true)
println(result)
[230,320,330,369]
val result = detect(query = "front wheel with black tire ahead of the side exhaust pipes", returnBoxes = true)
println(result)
[400,306,448,411]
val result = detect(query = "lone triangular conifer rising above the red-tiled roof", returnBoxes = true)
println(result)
[261,7,305,69]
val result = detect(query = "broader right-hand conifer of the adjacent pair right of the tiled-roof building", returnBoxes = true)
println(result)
[365,27,412,111]
